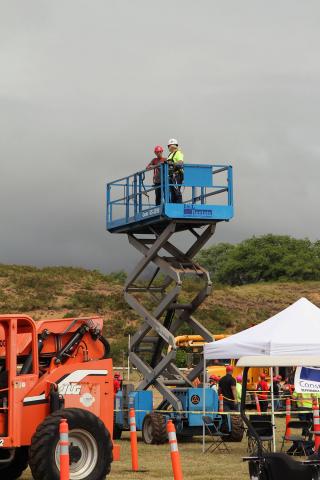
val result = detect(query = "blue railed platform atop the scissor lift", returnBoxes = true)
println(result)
[107,164,233,233]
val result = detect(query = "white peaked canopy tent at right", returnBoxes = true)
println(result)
[203,298,320,449]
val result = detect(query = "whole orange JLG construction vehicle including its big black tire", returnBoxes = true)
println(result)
[0,315,118,480]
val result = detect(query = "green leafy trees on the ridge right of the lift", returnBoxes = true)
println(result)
[197,234,320,285]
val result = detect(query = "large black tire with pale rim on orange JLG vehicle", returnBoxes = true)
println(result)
[29,408,113,480]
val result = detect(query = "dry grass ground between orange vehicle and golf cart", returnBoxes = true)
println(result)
[22,418,284,480]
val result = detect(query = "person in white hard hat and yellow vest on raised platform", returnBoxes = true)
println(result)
[167,138,184,203]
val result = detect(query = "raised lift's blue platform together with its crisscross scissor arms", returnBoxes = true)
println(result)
[107,164,233,411]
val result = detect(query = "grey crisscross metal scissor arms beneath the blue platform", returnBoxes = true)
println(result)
[124,221,216,411]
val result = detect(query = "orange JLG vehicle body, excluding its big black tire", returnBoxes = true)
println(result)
[0,315,114,448]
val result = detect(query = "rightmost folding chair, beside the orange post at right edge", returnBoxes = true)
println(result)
[281,420,311,456]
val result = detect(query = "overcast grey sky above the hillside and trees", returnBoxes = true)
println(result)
[0,0,320,271]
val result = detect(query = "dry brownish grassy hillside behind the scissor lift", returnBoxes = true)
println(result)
[0,265,320,361]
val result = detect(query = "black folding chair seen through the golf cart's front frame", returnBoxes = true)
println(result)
[247,415,273,455]
